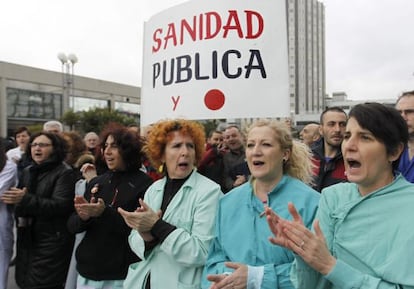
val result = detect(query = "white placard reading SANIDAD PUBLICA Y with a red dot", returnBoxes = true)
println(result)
[141,0,290,126]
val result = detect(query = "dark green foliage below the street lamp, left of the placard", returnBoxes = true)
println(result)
[61,108,136,133]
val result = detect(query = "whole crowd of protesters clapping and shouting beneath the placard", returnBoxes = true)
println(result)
[0,91,414,289]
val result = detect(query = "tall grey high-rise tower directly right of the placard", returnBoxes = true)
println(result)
[286,0,326,124]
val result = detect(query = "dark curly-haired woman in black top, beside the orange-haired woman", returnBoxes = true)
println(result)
[68,124,152,289]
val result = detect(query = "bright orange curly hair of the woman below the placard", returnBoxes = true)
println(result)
[144,119,206,168]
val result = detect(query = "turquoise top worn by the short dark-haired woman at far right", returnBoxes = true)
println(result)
[291,175,414,289]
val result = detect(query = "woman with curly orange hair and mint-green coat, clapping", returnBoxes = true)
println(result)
[118,119,222,289]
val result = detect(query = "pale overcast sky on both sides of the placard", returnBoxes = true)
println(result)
[0,0,414,99]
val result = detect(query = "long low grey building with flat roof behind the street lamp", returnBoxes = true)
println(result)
[0,61,141,136]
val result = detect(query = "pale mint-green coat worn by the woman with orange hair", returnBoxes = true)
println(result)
[124,171,222,289]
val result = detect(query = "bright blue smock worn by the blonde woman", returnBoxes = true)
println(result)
[202,175,320,289]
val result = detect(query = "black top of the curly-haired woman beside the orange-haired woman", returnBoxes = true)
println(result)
[68,170,152,281]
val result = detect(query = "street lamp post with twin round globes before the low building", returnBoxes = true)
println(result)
[58,52,78,112]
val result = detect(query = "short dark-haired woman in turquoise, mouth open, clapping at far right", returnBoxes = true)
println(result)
[266,103,414,289]
